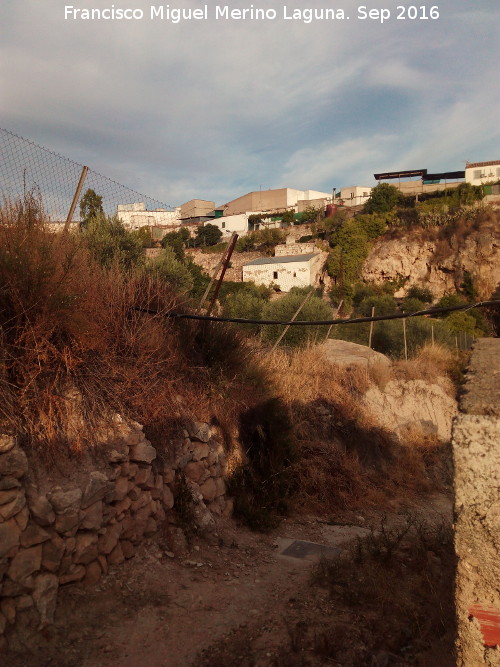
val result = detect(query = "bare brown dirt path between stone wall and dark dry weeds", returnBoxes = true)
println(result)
[6,498,449,667]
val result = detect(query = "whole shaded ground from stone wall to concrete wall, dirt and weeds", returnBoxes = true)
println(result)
[3,494,455,667]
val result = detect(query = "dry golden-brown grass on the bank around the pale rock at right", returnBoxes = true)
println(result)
[265,345,454,513]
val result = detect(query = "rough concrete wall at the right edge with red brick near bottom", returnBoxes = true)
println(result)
[452,338,500,667]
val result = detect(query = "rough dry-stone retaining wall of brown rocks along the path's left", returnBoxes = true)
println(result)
[0,417,232,649]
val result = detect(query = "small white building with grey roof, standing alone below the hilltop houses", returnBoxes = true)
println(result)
[243,253,322,292]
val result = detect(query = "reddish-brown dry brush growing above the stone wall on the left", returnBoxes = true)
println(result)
[0,200,265,457]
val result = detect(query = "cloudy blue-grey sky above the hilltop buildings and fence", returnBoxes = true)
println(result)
[0,0,500,206]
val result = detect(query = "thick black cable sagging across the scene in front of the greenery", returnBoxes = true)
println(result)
[134,300,500,326]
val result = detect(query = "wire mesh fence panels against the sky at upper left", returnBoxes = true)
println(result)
[0,128,177,227]
